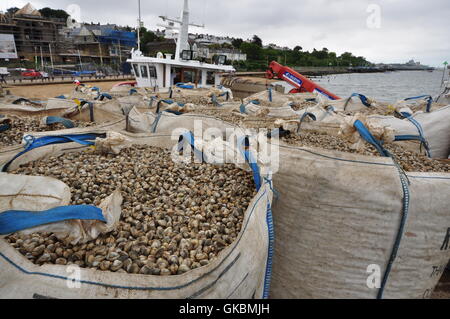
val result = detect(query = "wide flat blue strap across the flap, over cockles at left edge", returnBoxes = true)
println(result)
[0,205,106,235]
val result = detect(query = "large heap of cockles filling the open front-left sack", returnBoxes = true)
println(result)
[7,146,256,275]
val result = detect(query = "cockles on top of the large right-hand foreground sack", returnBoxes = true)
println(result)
[281,131,450,172]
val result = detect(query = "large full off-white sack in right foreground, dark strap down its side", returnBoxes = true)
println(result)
[271,116,450,298]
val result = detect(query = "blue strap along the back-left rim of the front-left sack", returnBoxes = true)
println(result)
[2,134,106,172]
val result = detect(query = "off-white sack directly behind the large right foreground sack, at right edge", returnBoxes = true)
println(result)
[298,94,450,158]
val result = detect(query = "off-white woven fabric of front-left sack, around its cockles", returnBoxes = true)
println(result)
[0,130,271,298]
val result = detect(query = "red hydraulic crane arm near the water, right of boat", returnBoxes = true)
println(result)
[266,61,341,100]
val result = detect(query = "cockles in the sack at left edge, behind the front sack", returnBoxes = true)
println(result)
[0,117,94,147]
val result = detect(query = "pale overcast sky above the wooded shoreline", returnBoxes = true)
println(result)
[0,0,450,66]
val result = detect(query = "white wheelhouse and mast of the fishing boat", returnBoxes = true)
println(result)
[127,0,236,92]
